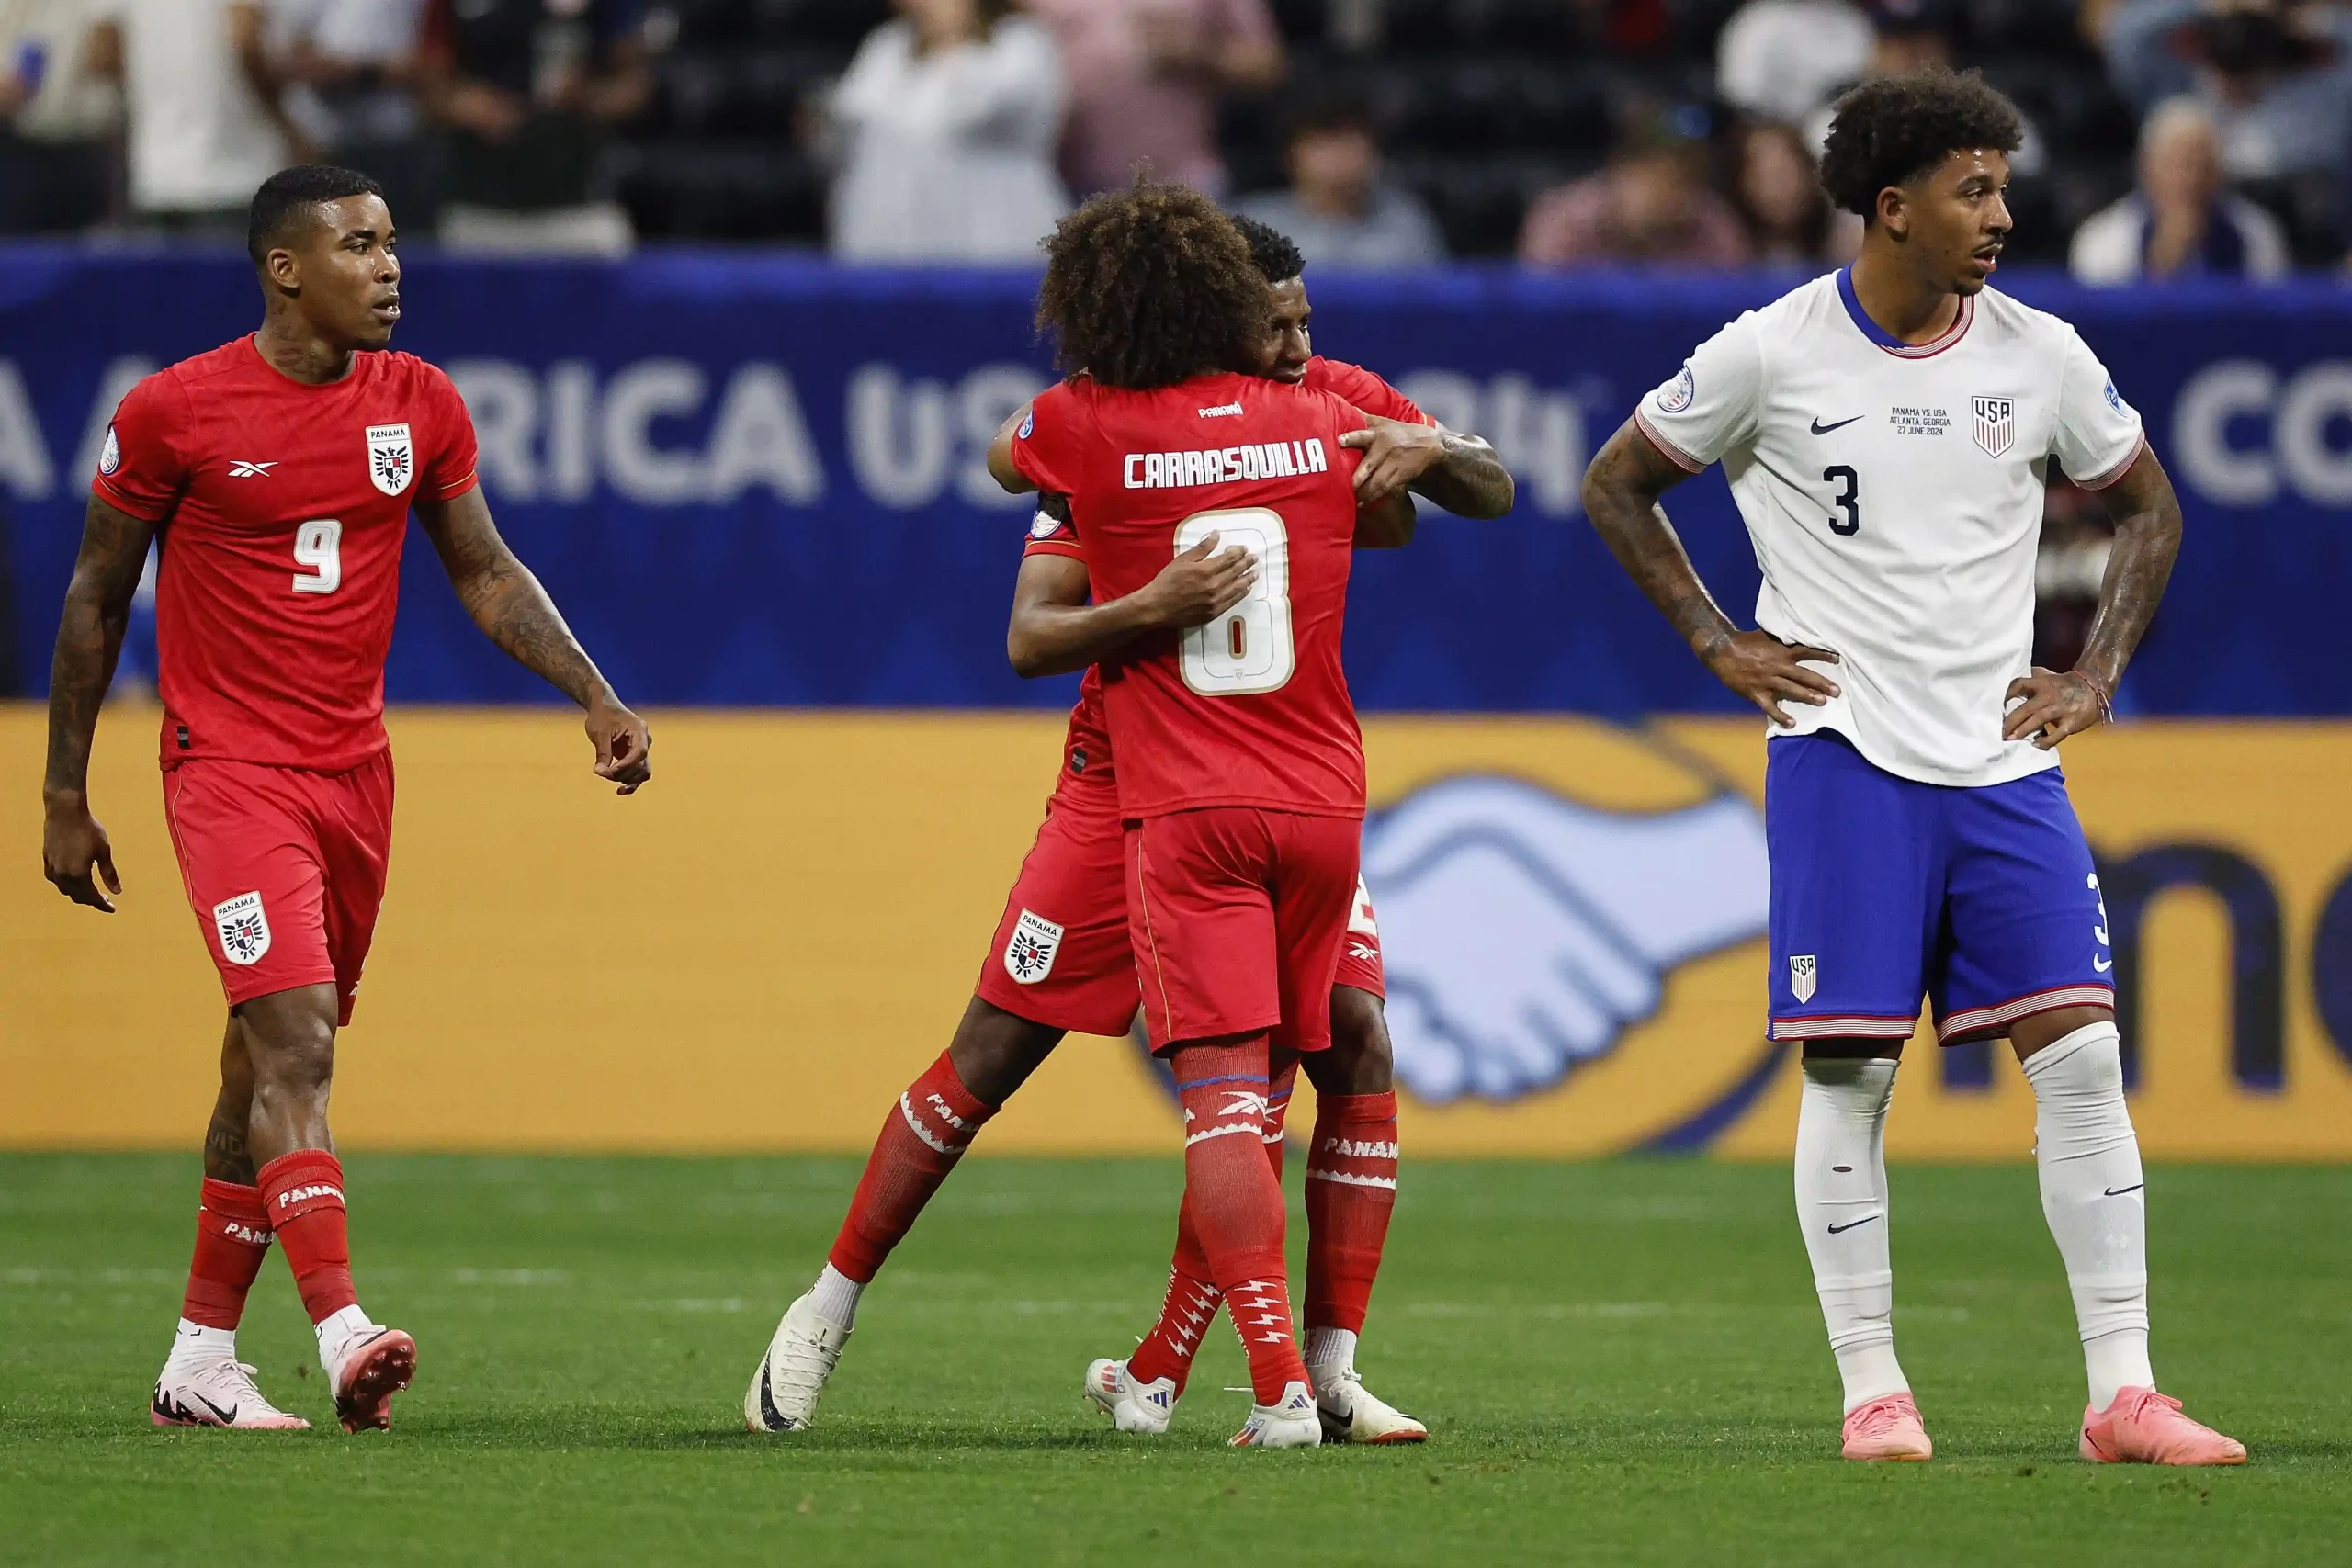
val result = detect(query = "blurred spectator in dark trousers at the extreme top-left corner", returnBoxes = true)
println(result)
[0,0,122,235]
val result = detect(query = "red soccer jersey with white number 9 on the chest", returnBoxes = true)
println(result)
[94,339,475,773]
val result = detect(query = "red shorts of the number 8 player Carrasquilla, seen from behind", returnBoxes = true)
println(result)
[1126,807,1364,1051]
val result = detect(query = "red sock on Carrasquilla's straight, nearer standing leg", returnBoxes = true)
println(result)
[1173,1034,1307,1405]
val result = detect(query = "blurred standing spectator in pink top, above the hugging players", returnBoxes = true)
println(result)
[1028,0,1284,195]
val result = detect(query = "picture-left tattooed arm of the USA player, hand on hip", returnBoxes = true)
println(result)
[1585,421,1837,727]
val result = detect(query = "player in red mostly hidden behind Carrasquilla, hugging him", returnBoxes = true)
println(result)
[743,219,1512,1443]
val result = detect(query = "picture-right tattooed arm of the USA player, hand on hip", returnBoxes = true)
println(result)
[2002,446,2180,750]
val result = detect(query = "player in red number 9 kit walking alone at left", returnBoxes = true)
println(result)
[42,164,651,1432]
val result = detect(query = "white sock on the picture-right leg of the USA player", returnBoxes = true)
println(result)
[2025,1022,2157,1411]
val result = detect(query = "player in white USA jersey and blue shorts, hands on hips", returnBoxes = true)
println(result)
[1585,71,2246,1464]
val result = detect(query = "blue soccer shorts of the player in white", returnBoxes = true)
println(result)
[1764,731,2114,1043]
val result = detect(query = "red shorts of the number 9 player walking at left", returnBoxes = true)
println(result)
[163,752,393,1022]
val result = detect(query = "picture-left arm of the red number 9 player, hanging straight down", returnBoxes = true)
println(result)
[40,496,155,915]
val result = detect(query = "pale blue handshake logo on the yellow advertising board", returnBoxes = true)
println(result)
[1364,776,1767,1105]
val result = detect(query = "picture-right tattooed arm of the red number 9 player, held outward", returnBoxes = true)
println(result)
[416,484,654,795]
